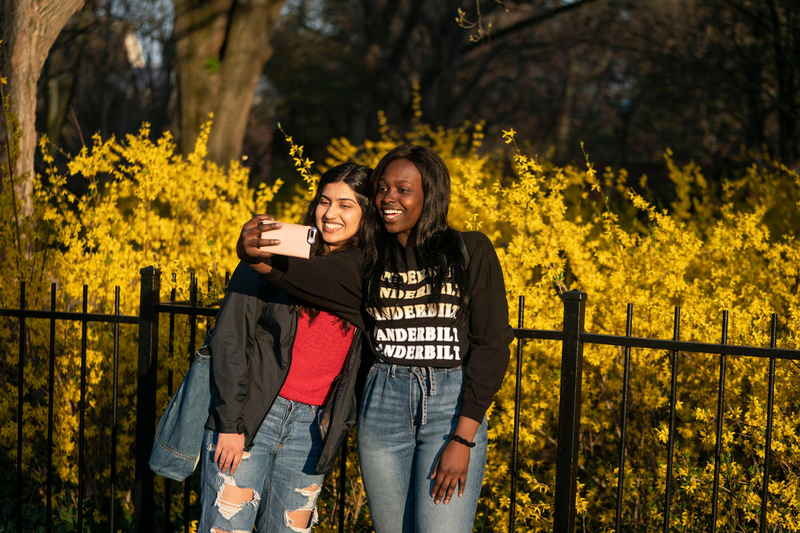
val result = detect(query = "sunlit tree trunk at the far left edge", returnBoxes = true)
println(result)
[0,0,84,215]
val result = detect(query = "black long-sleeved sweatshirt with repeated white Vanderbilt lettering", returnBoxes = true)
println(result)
[267,232,513,421]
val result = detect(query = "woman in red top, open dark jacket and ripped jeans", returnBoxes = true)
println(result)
[198,163,371,533]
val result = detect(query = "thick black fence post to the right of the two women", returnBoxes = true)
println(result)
[553,290,586,533]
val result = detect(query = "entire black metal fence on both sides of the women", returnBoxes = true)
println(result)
[0,267,800,533]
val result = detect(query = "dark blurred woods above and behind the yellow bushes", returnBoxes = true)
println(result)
[4,0,800,192]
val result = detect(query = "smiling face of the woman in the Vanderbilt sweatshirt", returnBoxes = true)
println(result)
[375,155,425,246]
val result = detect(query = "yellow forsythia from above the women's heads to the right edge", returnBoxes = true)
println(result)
[326,117,800,532]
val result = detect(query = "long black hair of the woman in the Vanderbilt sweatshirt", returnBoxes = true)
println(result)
[362,144,469,319]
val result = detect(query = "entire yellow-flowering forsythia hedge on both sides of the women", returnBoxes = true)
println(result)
[0,86,800,532]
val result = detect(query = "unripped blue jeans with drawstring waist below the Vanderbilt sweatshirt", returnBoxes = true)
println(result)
[358,361,487,533]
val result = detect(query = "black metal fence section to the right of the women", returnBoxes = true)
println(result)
[510,290,800,533]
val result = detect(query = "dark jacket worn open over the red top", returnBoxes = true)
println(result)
[206,263,361,473]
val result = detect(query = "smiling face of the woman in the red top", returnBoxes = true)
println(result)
[314,181,362,251]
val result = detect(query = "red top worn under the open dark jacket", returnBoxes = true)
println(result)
[280,311,354,405]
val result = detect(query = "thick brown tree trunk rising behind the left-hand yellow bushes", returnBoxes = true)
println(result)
[175,0,283,165]
